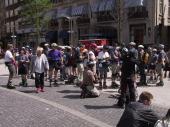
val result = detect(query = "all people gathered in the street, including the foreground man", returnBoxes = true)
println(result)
[4,42,170,127]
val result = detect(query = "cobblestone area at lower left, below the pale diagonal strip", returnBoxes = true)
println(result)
[0,90,97,127]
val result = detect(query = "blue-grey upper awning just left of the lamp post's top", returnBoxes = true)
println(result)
[57,8,71,18]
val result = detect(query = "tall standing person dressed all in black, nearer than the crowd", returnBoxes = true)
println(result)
[117,48,136,108]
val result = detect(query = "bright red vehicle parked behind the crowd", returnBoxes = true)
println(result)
[79,39,109,49]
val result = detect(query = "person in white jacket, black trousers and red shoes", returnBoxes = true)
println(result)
[34,47,49,93]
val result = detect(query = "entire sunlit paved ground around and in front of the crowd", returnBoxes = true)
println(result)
[0,61,170,127]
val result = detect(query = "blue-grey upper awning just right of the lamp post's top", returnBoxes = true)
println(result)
[72,5,88,16]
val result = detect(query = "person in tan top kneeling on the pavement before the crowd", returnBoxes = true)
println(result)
[80,62,100,98]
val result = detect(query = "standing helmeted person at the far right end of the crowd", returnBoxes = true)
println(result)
[156,44,167,86]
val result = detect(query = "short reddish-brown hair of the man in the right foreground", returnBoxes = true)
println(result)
[139,91,153,102]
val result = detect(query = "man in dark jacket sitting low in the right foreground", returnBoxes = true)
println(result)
[117,92,159,127]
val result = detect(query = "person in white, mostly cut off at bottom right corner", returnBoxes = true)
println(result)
[155,109,170,127]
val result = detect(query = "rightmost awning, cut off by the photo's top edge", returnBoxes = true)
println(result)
[124,0,146,8]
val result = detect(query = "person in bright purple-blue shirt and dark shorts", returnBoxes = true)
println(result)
[48,43,62,86]
